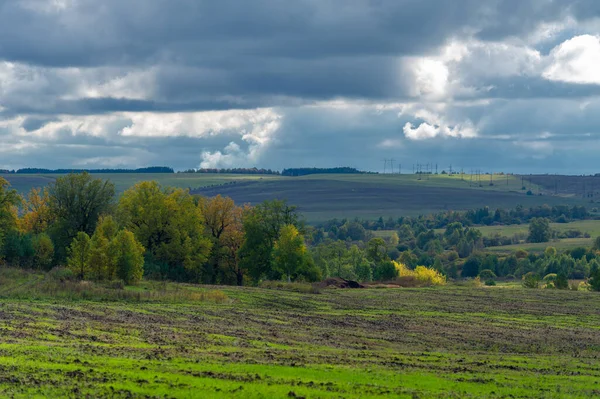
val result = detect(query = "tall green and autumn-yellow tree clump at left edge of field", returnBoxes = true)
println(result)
[0,172,321,285]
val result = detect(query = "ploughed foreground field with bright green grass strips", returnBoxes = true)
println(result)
[0,276,600,398]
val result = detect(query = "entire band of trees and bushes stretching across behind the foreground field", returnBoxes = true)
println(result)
[0,173,600,292]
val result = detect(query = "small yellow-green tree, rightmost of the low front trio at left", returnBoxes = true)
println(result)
[113,230,144,285]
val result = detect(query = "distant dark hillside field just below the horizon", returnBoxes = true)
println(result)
[3,173,587,222]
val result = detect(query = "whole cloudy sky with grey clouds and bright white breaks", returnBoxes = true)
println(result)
[0,0,600,174]
